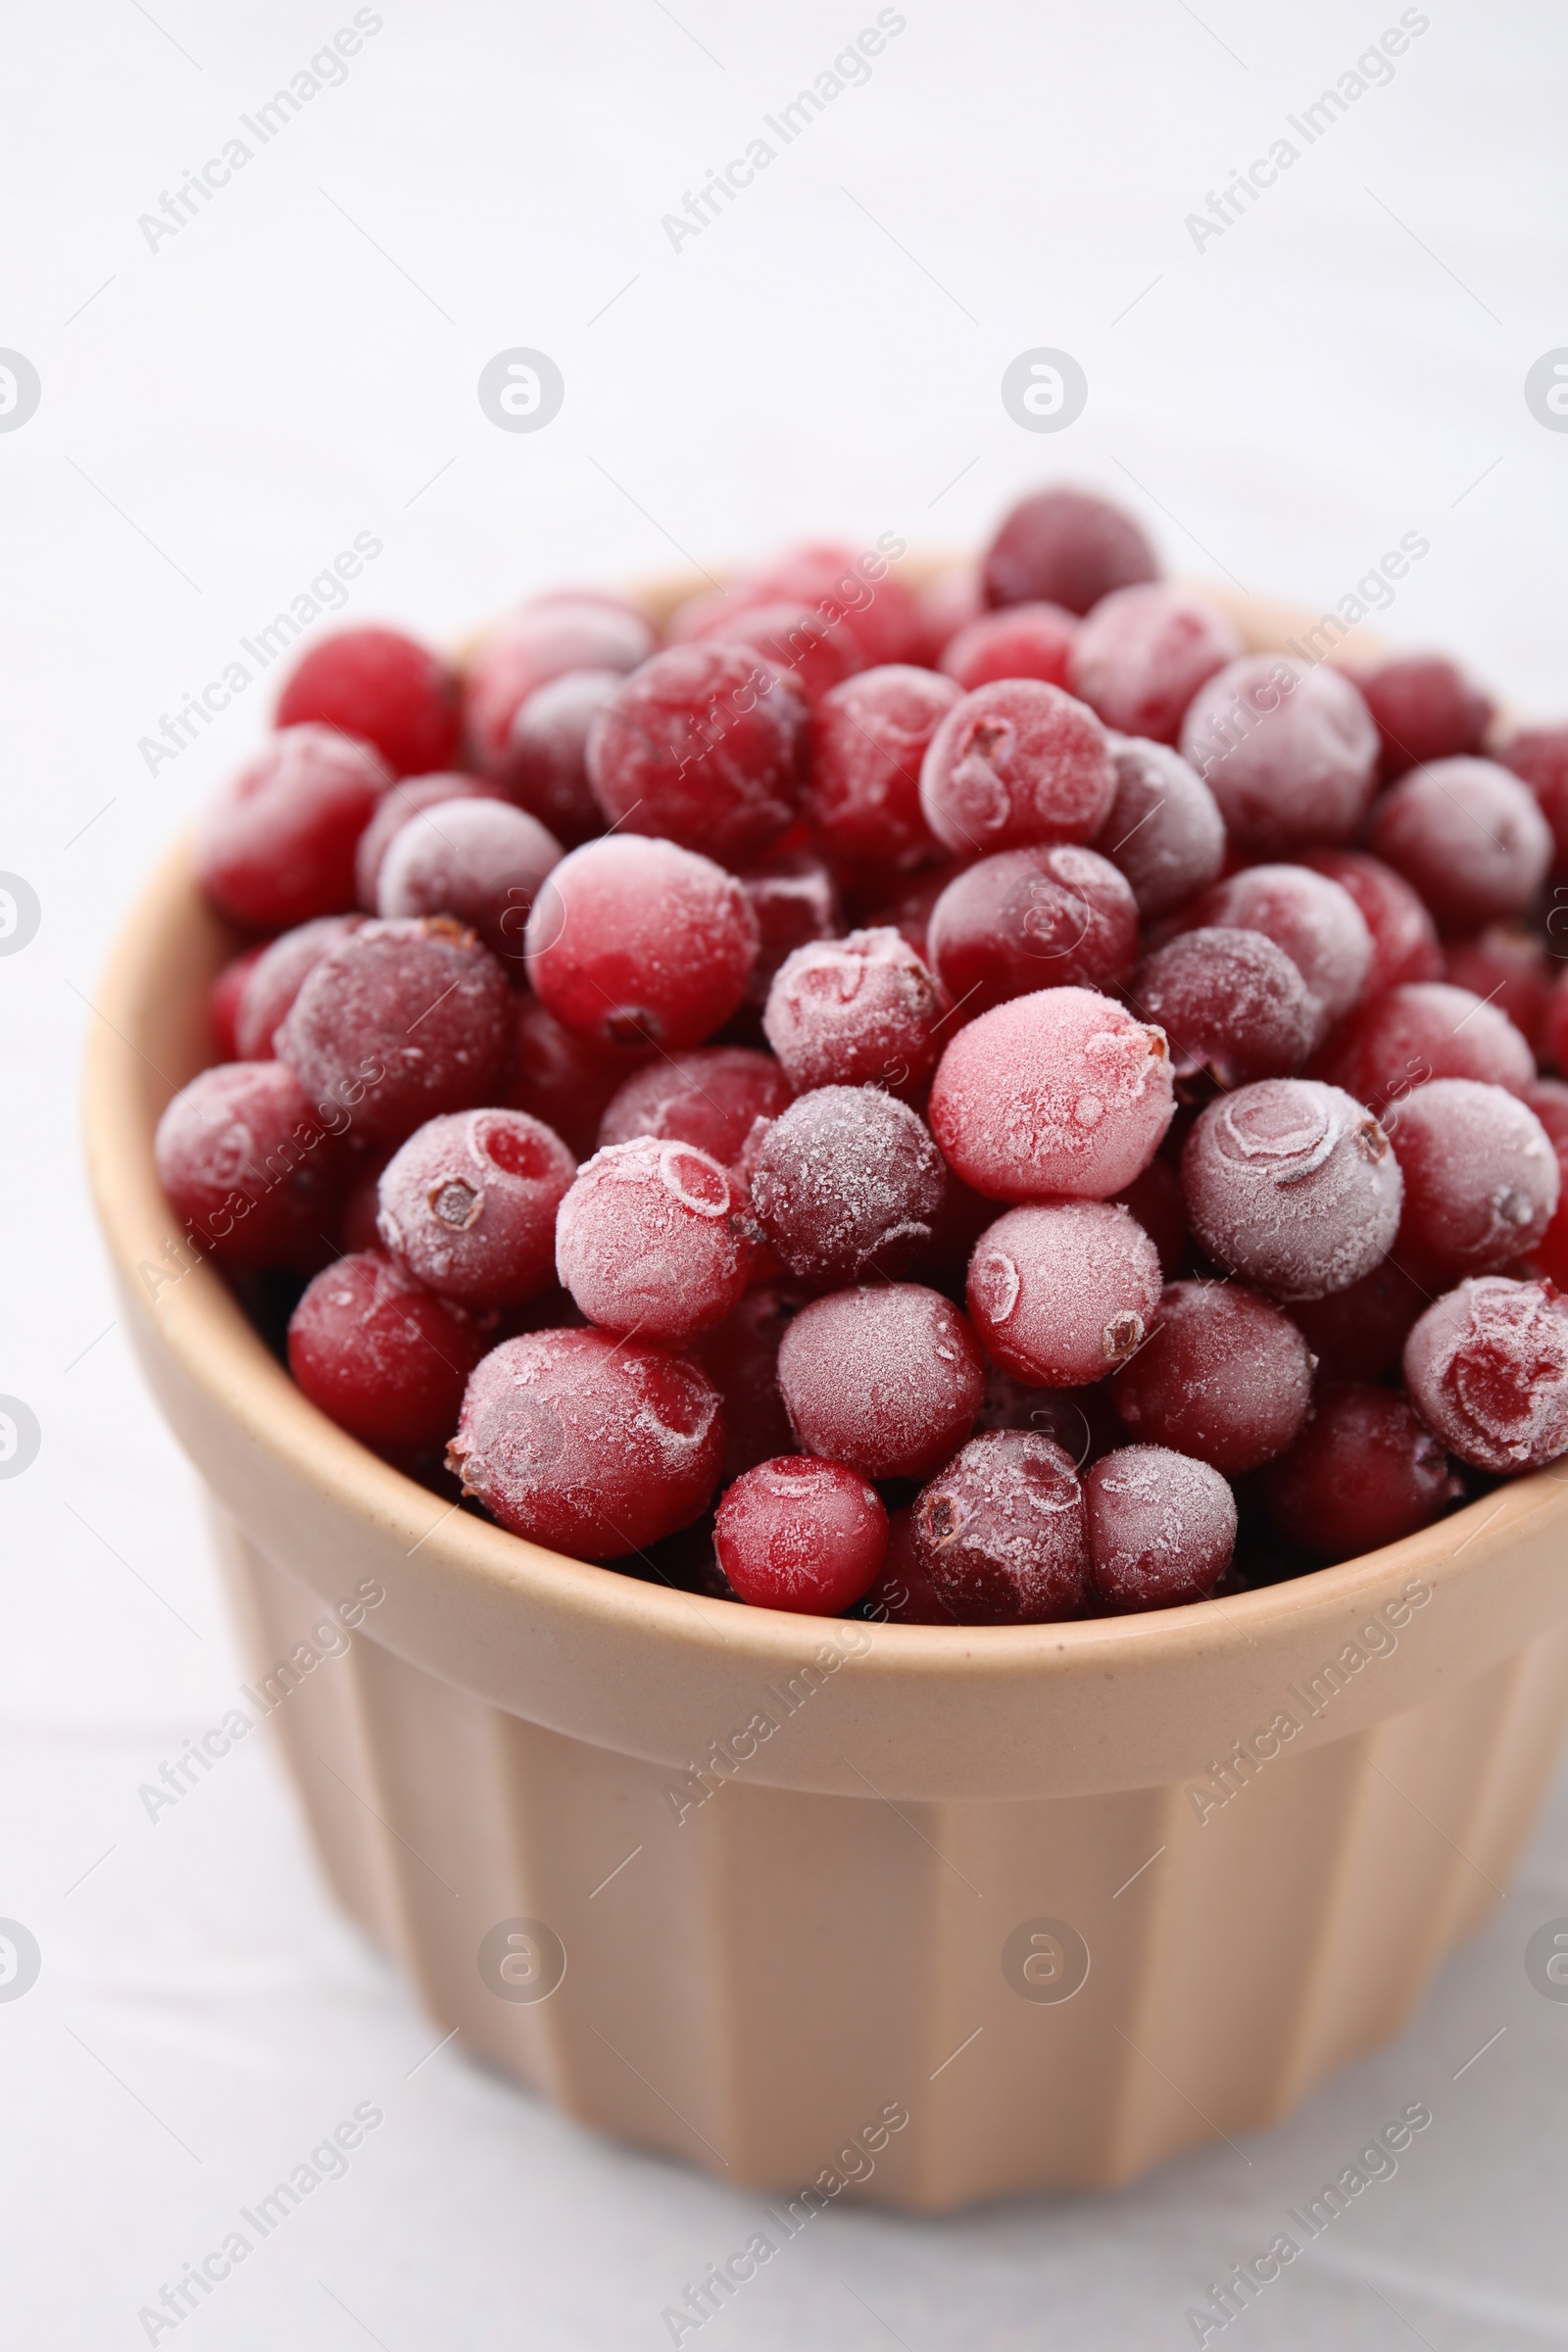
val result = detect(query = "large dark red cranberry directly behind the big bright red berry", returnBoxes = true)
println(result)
[588,645,807,868]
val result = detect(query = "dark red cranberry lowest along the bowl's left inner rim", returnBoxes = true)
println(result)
[289,1249,484,1453]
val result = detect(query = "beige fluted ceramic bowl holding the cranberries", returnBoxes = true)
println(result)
[87,588,1568,2211]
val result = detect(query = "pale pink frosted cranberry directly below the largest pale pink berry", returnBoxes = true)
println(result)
[968,1200,1161,1388]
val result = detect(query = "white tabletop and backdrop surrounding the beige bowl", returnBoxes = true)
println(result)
[0,0,1568,2352]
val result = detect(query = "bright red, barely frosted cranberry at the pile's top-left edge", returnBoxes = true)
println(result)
[277,628,464,776]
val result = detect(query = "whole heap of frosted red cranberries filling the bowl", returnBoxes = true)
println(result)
[158,487,1568,1625]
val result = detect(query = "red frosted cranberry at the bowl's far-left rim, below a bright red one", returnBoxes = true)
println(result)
[195,727,390,931]
